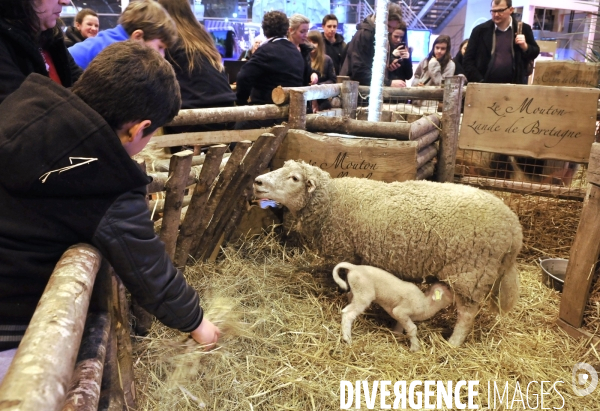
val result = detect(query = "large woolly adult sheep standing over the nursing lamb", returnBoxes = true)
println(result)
[254,160,523,346]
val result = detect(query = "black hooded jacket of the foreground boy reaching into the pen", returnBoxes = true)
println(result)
[0,74,202,349]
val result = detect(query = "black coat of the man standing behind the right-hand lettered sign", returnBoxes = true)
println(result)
[463,17,540,84]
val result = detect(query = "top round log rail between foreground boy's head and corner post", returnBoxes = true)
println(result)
[167,104,289,126]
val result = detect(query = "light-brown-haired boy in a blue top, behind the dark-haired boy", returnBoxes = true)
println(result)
[69,0,177,69]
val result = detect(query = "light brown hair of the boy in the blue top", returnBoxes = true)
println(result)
[119,0,177,47]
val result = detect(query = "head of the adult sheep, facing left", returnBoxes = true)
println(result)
[254,160,330,214]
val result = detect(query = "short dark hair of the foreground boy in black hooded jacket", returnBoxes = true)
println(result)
[72,40,181,136]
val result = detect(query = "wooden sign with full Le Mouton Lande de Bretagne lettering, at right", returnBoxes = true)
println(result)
[459,83,600,163]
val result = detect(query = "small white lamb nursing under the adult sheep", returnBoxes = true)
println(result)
[333,262,454,351]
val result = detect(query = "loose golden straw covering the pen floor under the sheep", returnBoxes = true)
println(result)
[134,227,600,411]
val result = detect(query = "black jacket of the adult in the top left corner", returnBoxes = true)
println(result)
[0,18,82,103]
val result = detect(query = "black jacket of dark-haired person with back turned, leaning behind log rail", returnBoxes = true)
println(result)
[236,37,310,105]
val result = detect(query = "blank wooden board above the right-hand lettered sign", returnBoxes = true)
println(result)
[533,60,600,88]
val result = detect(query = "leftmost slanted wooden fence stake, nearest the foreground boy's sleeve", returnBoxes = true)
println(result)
[160,150,194,259]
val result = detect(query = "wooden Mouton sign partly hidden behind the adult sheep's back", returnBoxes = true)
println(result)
[272,130,417,182]
